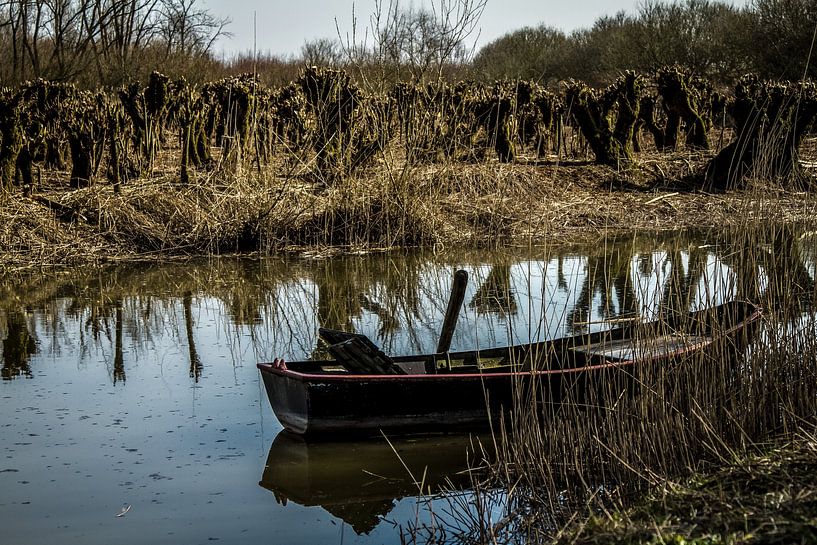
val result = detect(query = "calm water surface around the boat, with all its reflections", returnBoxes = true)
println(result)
[0,227,815,545]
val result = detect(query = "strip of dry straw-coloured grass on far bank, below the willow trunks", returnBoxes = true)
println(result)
[0,149,817,269]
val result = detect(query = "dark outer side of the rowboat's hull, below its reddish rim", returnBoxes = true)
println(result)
[259,363,632,435]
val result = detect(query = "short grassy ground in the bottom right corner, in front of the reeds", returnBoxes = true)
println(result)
[555,433,817,545]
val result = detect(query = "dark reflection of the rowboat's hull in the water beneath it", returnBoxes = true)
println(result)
[259,431,492,534]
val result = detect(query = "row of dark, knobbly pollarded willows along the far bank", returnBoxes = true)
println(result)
[0,66,817,199]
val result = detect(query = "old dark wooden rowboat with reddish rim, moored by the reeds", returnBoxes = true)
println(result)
[258,301,761,435]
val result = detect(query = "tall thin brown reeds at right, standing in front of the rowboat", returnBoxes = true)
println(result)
[420,231,817,543]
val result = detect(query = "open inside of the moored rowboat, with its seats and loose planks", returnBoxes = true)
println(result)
[268,302,758,375]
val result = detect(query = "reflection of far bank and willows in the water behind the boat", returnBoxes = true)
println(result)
[0,228,815,383]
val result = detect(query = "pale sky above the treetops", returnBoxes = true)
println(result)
[204,0,751,57]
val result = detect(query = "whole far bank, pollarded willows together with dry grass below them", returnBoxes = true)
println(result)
[0,66,817,266]
